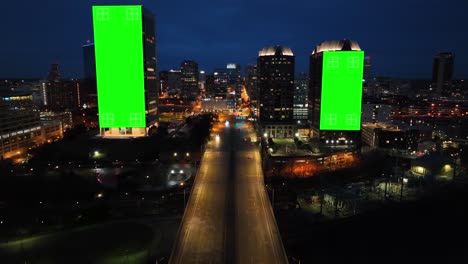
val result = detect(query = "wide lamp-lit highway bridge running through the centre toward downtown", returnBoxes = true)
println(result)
[169,119,288,264]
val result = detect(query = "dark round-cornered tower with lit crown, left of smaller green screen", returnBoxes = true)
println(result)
[257,46,295,138]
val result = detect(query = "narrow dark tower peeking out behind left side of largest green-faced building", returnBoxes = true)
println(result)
[81,43,97,108]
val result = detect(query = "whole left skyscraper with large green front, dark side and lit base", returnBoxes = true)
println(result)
[93,5,158,138]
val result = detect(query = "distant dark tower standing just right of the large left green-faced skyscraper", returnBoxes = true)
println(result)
[180,60,200,100]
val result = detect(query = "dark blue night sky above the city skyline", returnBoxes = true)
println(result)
[0,0,468,79]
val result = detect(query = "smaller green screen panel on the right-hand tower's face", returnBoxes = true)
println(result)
[320,51,364,130]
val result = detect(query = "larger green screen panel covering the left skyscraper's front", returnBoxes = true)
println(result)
[93,6,146,128]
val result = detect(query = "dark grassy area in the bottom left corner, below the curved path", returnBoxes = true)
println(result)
[0,222,155,263]
